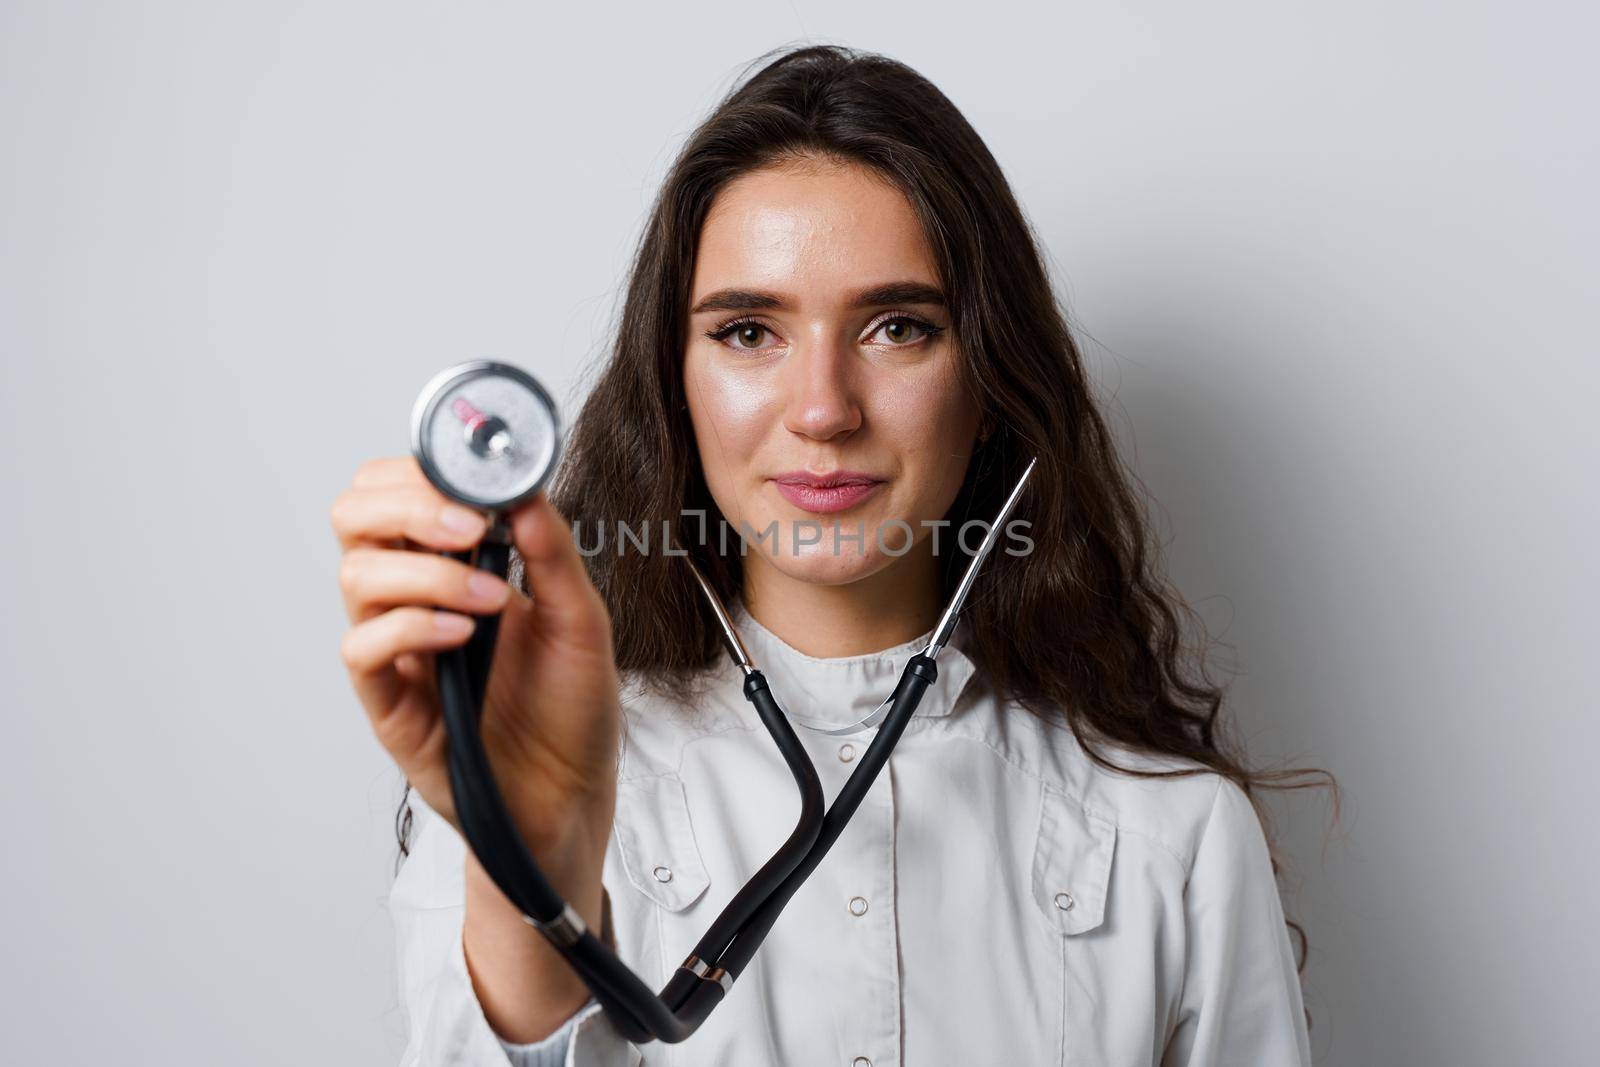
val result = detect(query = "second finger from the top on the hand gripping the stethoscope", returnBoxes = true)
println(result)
[339,545,510,622]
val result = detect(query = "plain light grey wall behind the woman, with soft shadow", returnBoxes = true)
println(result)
[0,0,1600,1067]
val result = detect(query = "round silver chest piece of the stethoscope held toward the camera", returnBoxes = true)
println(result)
[411,360,562,512]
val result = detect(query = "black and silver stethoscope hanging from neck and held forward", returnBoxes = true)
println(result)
[411,360,1037,1045]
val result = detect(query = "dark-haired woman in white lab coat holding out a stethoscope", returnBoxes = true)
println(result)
[333,48,1309,1067]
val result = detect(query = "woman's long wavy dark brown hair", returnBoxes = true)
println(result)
[398,45,1338,985]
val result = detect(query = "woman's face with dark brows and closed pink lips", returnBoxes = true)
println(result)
[683,163,979,584]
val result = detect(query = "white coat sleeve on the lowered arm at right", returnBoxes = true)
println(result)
[1162,779,1310,1067]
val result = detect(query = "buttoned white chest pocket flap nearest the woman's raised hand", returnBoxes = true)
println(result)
[613,774,710,912]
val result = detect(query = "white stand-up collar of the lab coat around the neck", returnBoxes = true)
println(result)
[730,601,978,726]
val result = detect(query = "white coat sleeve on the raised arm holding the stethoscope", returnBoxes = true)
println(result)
[389,795,643,1067]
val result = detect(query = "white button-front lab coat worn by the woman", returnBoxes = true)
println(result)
[390,605,1310,1067]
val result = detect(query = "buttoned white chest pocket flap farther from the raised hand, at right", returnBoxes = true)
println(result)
[1034,785,1117,934]
